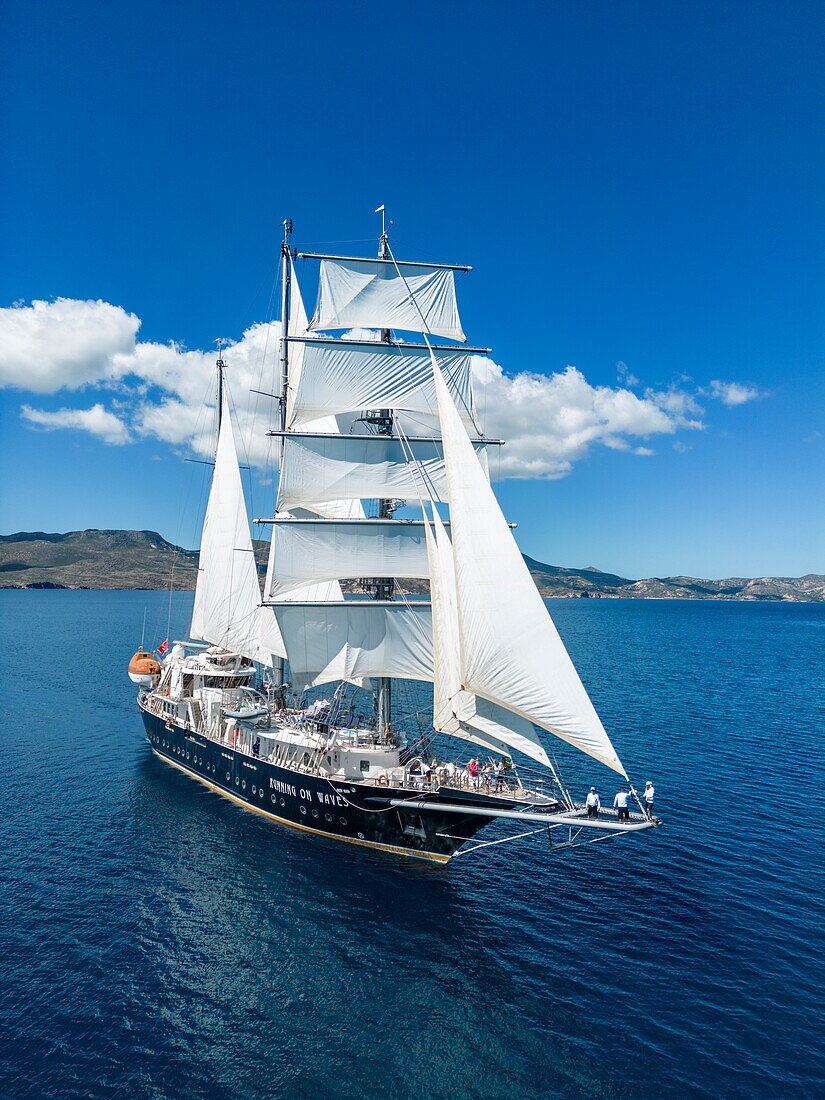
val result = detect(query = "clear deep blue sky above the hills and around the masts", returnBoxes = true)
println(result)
[0,0,825,576]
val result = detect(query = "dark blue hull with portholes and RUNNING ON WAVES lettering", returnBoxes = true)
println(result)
[141,707,530,864]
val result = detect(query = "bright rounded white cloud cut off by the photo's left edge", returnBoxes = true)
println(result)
[0,298,141,394]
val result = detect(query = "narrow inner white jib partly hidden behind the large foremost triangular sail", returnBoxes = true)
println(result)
[426,507,550,766]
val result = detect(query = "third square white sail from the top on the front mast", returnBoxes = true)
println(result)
[278,431,484,512]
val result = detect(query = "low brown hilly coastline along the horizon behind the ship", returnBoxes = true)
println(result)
[0,530,825,602]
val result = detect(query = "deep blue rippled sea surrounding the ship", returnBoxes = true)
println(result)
[0,592,825,1100]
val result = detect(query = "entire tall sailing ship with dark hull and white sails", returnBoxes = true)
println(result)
[130,211,659,864]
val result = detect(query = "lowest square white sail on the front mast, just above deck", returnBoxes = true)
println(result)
[274,600,432,684]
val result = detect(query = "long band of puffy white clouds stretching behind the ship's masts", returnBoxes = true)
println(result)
[0,298,761,477]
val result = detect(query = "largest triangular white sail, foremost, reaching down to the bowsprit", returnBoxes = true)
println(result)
[432,359,626,776]
